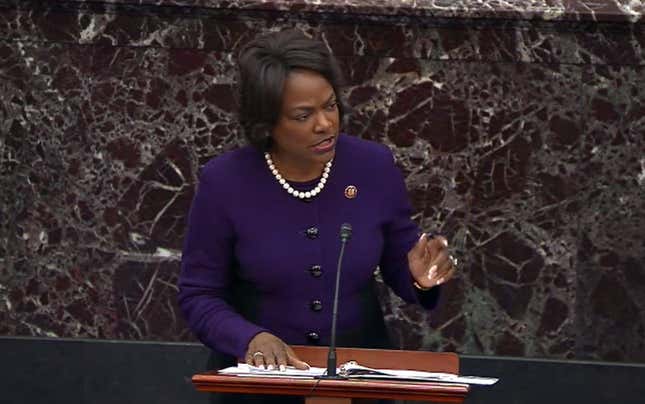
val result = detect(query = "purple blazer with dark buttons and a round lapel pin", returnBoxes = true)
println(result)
[179,134,437,357]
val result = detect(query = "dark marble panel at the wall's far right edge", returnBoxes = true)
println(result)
[576,66,645,362]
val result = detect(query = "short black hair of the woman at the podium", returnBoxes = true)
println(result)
[238,29,345,151]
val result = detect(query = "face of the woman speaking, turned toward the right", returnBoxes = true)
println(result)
[272,70,340,169]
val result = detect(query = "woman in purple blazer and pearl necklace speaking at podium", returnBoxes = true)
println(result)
[179,30,455,402]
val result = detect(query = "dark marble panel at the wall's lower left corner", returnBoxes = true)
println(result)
[0,248,115,338]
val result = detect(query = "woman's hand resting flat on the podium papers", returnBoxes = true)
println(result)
[245,332,309,371]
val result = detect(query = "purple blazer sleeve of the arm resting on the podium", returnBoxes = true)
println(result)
[178,166,266,358]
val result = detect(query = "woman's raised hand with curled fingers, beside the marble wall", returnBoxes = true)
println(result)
[408,233,457,288]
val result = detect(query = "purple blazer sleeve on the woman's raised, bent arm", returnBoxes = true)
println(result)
[380,150,440,309]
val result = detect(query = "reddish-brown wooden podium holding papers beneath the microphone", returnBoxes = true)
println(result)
[192,346,469,404]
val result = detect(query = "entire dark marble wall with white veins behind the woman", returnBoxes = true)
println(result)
[0,0,645,362]
